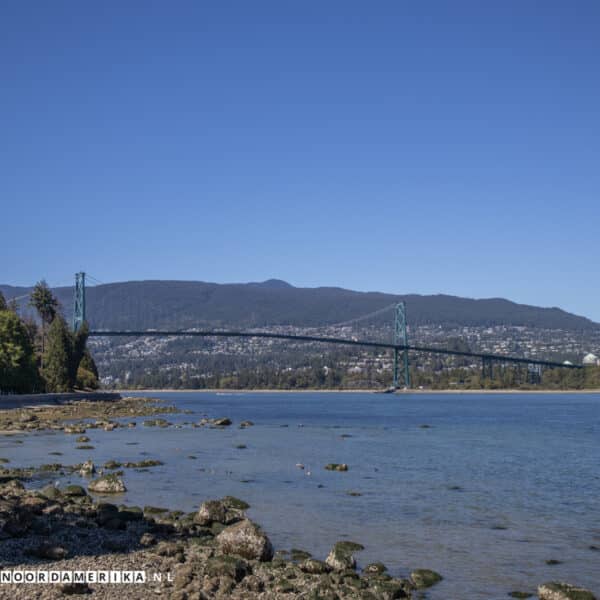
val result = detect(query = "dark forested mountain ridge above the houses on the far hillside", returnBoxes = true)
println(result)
[0,279,600,331]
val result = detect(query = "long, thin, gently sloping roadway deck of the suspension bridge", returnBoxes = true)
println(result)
[90,330,583,369]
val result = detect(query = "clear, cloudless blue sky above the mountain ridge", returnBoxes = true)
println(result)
[0,0,600,321]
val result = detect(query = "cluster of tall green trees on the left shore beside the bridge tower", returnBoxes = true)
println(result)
[0,281,98,394]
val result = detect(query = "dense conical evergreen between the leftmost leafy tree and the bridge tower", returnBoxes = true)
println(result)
[42,315,72,392]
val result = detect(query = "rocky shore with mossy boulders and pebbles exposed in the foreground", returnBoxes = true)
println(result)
[0,397,595,600]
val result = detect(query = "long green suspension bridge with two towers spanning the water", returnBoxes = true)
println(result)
[61,272,583,389]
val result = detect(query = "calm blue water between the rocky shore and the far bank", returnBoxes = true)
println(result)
[0,393,600,600]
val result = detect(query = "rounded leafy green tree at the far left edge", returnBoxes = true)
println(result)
[0,310,40,393]
